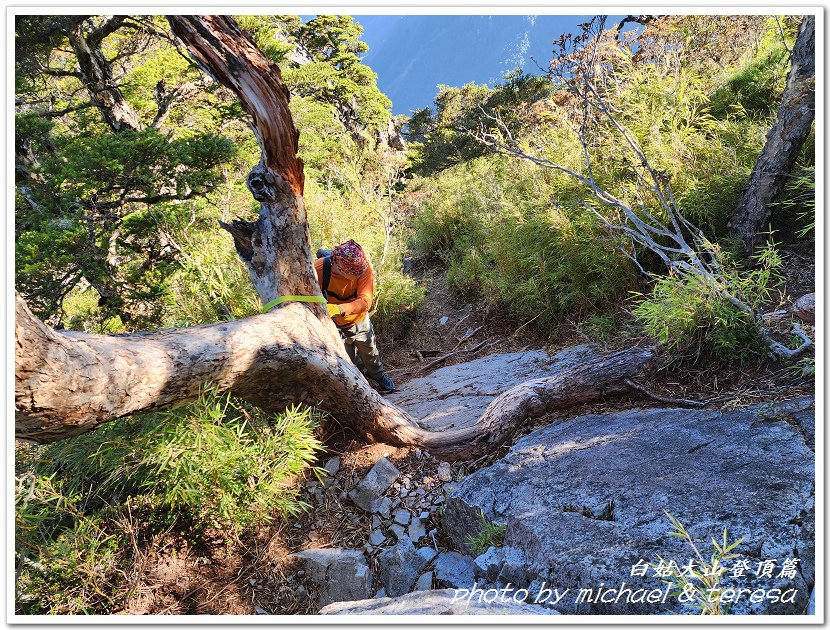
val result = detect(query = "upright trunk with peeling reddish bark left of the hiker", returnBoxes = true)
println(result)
[169,16,316,304]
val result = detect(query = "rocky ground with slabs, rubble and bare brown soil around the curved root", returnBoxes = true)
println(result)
[120,257,815,615]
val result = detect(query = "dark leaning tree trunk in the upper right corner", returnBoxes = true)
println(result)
[729,15,816,252]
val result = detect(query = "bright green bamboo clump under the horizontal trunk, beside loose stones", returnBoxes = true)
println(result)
[44,389,321,531]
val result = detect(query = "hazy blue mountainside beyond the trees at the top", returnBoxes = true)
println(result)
[355,15,600,115]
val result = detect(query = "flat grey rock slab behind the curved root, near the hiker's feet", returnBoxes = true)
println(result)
[386,344,597,431]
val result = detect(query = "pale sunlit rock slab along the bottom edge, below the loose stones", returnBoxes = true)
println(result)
[320,589,559,615]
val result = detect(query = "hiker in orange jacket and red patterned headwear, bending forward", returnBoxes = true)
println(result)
[314,239,395,393]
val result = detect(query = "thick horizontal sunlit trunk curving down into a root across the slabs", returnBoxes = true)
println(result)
[15,288,652,459]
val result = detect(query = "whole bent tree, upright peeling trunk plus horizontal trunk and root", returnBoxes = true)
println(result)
[15,16,651,459]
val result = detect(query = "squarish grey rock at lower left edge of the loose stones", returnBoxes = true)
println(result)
[291,548,372,606]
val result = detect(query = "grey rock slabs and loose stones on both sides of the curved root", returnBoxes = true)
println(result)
[249,346,815,614]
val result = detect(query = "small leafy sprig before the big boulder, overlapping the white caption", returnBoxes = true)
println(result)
[653,512,743,615]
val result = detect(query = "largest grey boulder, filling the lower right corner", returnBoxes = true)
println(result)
[442,398,815,614]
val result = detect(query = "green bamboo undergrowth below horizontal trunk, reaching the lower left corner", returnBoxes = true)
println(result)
[15,389,321,614]
